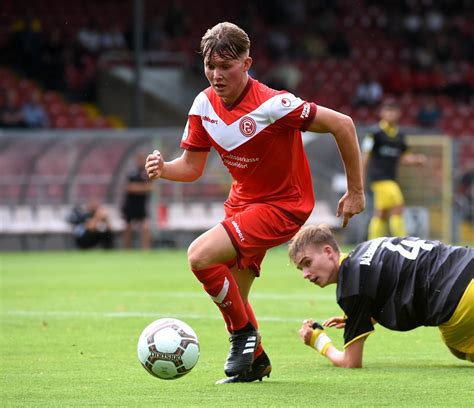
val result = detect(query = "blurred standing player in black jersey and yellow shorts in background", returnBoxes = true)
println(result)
[362,102,426,239]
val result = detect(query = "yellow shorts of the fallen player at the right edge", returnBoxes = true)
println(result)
[439,279,474,353]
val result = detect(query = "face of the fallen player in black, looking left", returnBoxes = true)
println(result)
[296,245,339,288]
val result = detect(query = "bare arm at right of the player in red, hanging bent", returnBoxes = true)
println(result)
[308,106,365,227]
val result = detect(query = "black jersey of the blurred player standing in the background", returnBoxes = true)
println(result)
[362,121,408,182]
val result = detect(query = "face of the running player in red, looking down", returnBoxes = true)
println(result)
[204,54,252,105]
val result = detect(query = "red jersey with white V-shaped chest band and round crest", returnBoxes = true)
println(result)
[181,77,316,224]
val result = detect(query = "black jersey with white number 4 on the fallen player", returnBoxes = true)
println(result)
[337,237,474,346]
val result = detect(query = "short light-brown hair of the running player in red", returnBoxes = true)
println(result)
[201,21,250,61]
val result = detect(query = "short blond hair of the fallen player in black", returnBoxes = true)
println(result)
[288,224,341,262]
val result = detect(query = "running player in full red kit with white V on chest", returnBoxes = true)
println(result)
[145,22,365,383]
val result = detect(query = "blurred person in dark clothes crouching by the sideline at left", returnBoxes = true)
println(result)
[67,199,114,249]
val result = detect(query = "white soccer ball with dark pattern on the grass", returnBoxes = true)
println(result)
[137,318,199,380]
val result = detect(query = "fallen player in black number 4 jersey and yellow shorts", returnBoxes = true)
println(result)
[289,226,474,367]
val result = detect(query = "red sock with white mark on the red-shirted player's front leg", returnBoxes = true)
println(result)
[193,265,249,332]
